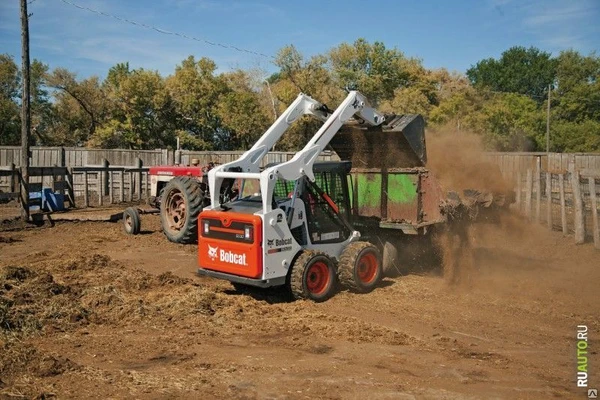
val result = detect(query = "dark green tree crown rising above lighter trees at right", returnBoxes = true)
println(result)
[467,46,557,103]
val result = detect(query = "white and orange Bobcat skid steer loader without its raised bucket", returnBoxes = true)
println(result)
[198,91,385,301]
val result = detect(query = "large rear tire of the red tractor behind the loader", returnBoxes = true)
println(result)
[160,176,204,244]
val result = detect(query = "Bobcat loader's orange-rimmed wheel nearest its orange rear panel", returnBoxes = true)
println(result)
[289,251,336,302]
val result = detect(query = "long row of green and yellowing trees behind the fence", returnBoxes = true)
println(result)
[0,39,600,151]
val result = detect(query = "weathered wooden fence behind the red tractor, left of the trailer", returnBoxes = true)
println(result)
[0,147,337,211]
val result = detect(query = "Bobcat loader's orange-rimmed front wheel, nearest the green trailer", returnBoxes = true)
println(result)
[338,242,383,293]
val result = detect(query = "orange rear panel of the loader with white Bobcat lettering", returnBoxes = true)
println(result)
[198,210,263,279]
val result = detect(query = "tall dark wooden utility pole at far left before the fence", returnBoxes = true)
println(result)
[21,0,31,222]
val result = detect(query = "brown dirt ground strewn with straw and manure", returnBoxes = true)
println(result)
[0,208,600,399]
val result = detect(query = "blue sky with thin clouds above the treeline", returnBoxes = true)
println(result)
[0,0,600,77]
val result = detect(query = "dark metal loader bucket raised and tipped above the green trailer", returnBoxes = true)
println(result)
[330,114,427,169]
